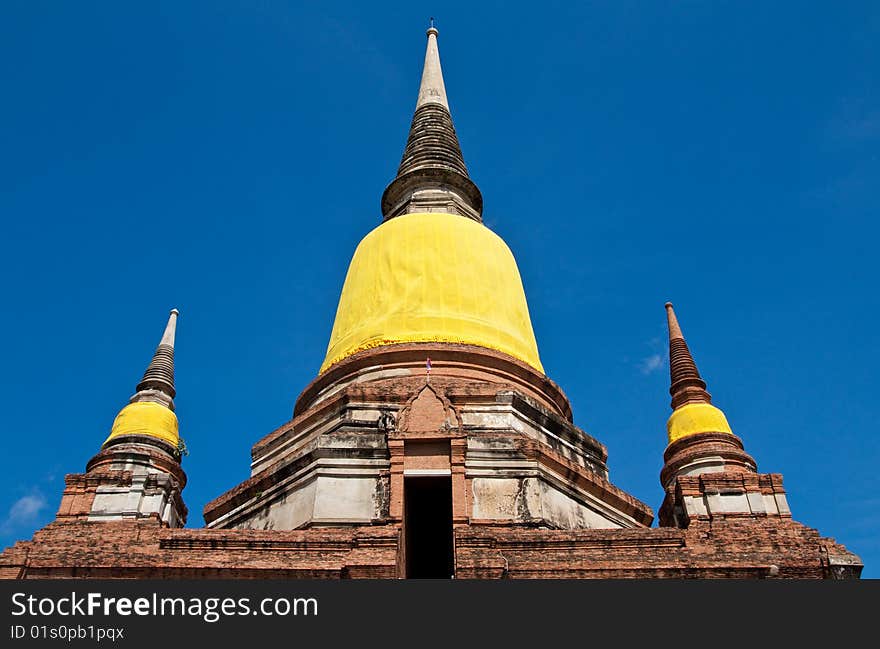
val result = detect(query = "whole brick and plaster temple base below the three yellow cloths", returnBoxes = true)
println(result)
[0,344,861,579]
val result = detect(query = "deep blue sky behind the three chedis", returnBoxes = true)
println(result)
[0,1,880,577]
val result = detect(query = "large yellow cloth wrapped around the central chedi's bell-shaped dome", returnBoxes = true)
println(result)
[321,213,544,373]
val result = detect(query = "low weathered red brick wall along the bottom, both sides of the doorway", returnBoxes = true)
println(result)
[0,518,858,579]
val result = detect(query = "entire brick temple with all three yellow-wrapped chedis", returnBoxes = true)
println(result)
[0,27,861,578]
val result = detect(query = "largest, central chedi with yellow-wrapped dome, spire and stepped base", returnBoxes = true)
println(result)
[205,28,652,548]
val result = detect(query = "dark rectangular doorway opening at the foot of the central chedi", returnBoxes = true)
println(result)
[403,477,455,579]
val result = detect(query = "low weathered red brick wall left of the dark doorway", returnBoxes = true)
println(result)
[0,520,399,579]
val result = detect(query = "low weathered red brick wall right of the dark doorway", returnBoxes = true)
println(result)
[455,519,842,579]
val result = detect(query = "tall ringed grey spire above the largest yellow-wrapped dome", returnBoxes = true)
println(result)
[382,19,483,221]
